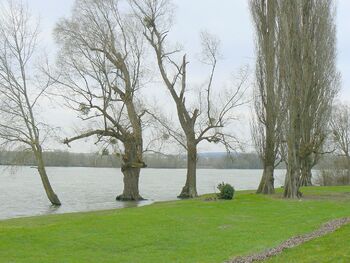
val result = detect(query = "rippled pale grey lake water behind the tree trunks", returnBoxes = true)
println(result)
[0,167,285,220]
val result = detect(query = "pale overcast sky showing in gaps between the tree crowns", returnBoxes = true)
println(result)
[23,0,350,154]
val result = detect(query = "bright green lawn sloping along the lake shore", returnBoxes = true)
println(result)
[0,187,350,263]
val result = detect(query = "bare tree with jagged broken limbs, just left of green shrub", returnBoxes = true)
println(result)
[130,0,247,198]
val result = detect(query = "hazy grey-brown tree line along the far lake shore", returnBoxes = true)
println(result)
[0,151,262,169]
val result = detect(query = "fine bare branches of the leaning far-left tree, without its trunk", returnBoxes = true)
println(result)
[0,1,43,146]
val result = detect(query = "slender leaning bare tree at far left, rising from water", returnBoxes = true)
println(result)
[0,1,61,205]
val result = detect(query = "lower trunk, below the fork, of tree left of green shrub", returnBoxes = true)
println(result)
[178,141,198,198]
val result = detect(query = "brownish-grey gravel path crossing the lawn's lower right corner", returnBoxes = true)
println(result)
[227,217,350,263]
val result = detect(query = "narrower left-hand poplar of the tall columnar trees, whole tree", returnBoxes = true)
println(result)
[250,0,285,194]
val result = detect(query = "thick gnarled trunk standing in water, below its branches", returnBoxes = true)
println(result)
[116,137,146,201]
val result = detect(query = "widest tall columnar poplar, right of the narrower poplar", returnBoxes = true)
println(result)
[278,0,337,198]
